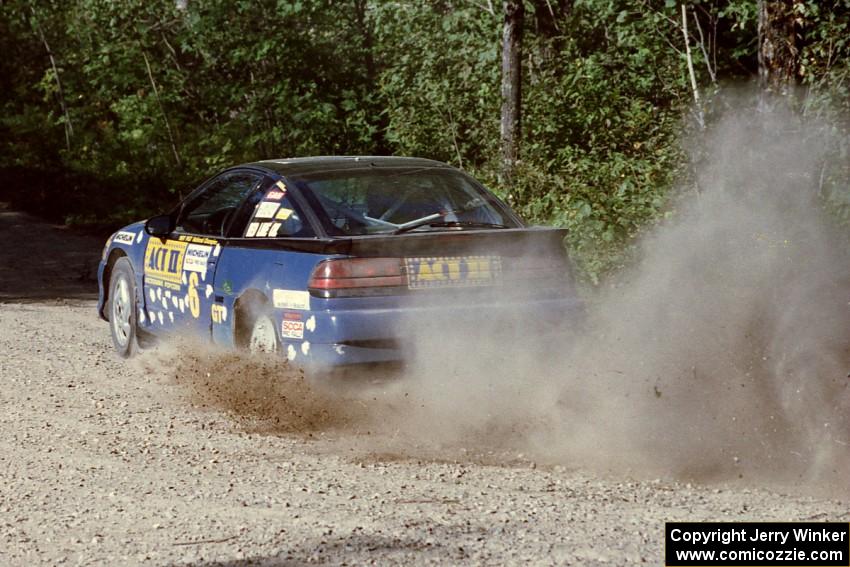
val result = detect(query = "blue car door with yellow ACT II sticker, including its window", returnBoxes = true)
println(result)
[143,170,262,334]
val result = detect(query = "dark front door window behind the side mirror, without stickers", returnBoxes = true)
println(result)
[177,172,260,237]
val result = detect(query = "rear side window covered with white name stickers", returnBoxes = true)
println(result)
[245,181,316,238]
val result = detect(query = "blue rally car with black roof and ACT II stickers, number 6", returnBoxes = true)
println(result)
[98,157,580,371]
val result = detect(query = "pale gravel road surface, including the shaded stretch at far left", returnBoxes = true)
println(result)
[0,206,848,565]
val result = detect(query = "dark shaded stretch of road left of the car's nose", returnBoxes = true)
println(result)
[0,203,105,303]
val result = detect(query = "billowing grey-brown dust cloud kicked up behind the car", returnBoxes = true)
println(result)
[149,104,850,492]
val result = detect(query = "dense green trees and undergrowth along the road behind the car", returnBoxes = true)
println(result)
[0,0,850,283]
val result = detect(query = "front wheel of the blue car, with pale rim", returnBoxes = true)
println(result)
[107,258,139,358]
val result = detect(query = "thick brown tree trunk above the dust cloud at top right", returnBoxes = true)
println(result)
[758,0,802,94]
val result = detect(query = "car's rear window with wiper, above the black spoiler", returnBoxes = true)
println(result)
[295,167,519,236]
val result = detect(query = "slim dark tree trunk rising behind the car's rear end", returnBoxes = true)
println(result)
[501,0,525,187]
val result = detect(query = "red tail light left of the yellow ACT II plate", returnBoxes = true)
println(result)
[309,258,407,297]
